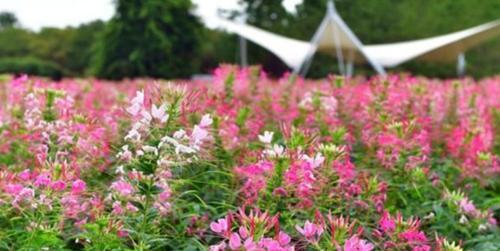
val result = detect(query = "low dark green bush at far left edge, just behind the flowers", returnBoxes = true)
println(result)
[0,57,64,80]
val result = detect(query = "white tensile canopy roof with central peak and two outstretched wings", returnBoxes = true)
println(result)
[211,4,500,73]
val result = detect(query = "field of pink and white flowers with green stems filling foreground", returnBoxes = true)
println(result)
[0,66,500,251]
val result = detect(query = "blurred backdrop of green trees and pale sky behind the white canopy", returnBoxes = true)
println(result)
[0,0,500,79]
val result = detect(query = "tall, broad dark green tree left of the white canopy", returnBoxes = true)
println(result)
[94,0,202,79]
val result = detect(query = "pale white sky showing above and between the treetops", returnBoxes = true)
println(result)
[0,0,302,31]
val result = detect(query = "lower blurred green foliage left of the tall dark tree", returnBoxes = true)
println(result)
[0,21,104,78]
